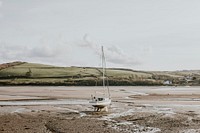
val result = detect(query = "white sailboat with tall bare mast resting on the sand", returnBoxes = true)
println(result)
[89,46,111,111]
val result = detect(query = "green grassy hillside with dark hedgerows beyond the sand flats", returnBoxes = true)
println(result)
[0,62,200,86]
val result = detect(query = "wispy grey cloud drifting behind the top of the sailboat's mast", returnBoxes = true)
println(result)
[79,34,141,66]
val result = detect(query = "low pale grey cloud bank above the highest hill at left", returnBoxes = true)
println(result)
[0,34,68,64]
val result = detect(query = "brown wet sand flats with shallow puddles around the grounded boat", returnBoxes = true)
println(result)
[0,86,200,133]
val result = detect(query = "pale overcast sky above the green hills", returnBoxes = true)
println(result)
[0,0,200,71]
